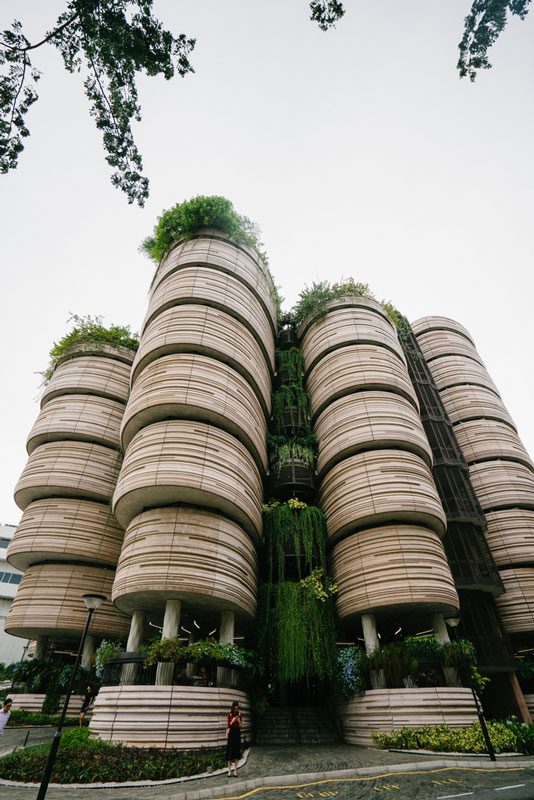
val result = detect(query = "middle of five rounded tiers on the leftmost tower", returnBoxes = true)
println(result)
[15,442,121,511]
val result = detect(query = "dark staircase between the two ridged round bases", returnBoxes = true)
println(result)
[255,706,339,746]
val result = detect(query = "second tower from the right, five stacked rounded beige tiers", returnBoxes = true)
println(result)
[299,297,458,636]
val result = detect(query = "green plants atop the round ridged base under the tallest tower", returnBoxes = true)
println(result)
[145,636,255,672]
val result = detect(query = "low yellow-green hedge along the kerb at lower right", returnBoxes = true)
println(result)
[372,722,534,753]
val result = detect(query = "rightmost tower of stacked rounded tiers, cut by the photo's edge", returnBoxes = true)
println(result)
[412,317,534,642]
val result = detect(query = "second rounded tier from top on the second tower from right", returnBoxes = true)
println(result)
[306,344,419,418]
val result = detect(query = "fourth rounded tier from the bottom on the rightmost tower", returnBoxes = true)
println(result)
[454,419,534,470]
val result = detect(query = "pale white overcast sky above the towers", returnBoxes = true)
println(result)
[0,0,534,523]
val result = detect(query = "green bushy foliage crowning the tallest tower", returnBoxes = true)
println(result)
[142,195,266,262]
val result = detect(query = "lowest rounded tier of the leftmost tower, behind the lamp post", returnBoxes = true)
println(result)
[5,564,130,641]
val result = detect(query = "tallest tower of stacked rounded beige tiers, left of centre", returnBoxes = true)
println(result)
[113,231,276,648]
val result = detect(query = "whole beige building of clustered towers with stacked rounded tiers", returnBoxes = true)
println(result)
[6,230,534,747]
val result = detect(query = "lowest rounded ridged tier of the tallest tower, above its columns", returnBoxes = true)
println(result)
[113,508,258,619]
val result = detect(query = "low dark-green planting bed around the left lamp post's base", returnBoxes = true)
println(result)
[0,728,226,784]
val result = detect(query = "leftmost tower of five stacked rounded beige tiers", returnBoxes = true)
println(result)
[5,344,134,648]
